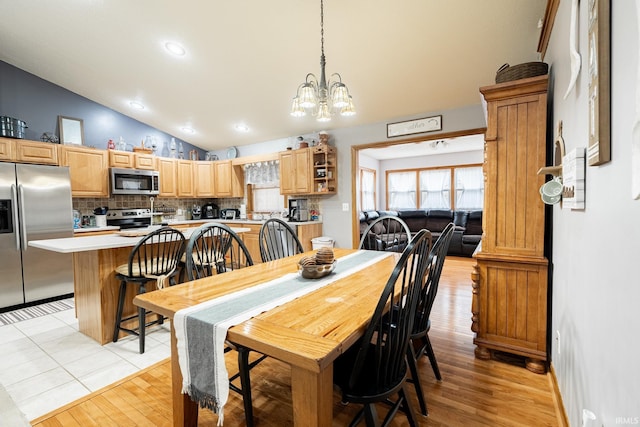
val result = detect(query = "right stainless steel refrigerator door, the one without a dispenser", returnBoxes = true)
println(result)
[16,164,73,302]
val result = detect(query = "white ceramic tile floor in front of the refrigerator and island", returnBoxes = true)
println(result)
[0,309,170,424]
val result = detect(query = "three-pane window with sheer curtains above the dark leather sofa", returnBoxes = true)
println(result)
[386,165,484,210]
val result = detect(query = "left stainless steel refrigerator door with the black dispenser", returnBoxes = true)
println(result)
[0,163,24,308]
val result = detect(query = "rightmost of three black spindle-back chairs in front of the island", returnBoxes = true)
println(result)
[258,218,304,262]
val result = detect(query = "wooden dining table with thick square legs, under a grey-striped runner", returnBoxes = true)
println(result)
[133,248,400,427]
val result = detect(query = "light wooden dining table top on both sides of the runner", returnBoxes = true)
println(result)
[134,248,399,372]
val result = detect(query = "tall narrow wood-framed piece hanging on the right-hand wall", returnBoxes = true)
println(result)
[587,0,611,166]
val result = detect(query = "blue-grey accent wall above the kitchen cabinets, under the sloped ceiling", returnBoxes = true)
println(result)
[0,61,205,159]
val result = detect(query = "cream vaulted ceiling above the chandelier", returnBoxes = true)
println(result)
[0,0,547,150]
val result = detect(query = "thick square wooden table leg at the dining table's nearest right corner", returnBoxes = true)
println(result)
[291,364,333,427]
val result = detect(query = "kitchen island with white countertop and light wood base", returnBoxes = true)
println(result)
[29,226,249,345]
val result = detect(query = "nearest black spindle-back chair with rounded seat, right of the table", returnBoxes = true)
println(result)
[334,230,431,426]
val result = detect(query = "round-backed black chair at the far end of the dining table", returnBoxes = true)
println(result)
[358,215,411,252]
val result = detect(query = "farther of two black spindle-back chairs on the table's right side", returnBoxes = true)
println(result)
[407,222,455,415]
